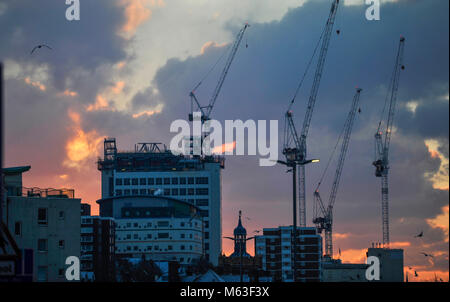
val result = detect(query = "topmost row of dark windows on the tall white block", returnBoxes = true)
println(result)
[116,177,209,186]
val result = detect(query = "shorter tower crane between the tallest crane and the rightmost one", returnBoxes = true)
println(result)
[313,88,362,258]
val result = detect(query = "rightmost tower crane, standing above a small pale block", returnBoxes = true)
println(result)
[373,36,405,248]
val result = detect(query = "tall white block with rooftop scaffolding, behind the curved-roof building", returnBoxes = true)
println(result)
[98,138,224,265]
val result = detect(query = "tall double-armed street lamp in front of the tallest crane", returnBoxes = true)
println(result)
[277,155,320,282]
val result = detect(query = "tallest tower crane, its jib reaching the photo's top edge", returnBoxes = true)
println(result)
[283,0,339,227]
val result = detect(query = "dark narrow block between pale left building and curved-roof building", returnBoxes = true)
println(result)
[80,216,116,282]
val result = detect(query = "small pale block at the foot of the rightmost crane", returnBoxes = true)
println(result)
[367,244,404,282]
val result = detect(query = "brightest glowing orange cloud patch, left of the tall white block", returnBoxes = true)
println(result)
[62,111,103,170]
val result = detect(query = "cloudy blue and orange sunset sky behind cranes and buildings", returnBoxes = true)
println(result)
[0,0,449,281]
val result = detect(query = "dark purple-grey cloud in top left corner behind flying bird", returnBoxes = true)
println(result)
[0,0,126,97]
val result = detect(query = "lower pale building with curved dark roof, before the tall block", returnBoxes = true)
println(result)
[97,196,203,267]
